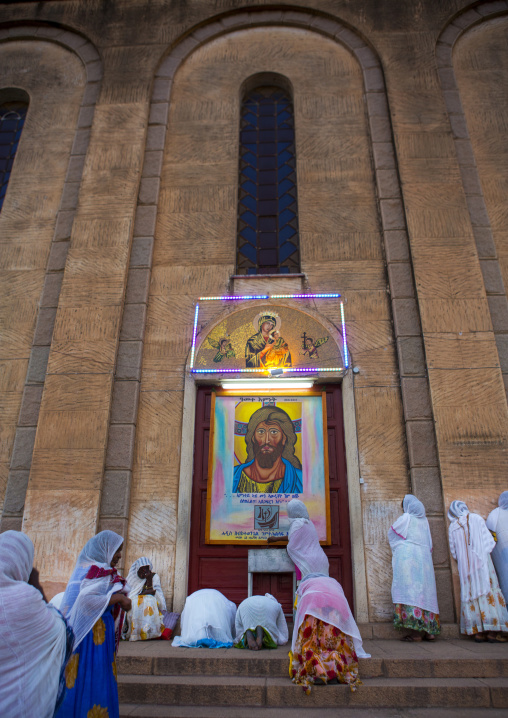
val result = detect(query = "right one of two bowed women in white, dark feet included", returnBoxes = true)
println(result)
[235,593,288,651]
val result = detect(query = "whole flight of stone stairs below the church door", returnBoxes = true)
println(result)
[117,639,508,718]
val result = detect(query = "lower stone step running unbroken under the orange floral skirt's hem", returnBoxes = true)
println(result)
[118,675,508,709]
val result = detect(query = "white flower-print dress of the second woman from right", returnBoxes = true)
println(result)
[460,556,508,635]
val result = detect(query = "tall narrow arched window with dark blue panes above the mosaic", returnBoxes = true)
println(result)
[236,84,300,274]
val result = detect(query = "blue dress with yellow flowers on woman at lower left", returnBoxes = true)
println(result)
[55,606,119,718]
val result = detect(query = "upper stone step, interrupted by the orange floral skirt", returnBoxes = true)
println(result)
[117,641,508,679]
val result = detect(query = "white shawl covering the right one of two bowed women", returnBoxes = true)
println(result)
[235,593,288,646]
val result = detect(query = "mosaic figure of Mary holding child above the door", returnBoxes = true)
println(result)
[245,310,292,369]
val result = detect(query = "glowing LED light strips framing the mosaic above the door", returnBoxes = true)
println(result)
[190,293,349,375]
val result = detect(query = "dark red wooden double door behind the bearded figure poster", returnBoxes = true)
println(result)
[188,384,354,614]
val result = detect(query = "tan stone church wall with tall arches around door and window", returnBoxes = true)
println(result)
[0,0,508,620]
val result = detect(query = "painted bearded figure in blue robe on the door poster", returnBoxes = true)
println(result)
[233,406,303,494]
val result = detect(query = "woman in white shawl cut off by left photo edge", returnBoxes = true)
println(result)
[0,531,73,718]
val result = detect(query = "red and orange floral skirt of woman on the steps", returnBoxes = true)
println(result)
[289,615,361,694]
